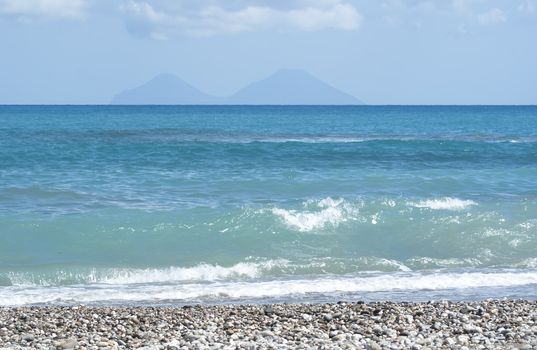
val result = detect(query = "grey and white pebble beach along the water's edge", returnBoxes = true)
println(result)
[0,300,537,350]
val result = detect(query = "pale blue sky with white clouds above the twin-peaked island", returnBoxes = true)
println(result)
[0,0,537,104]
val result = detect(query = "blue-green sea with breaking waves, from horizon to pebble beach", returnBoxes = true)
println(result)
[0,106,537,306]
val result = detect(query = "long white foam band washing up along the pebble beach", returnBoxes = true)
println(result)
[0,270,537,306]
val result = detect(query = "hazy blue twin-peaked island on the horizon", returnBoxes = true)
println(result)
[111,69,363,105]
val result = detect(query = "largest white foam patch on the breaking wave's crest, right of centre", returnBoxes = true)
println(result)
[272,197,358,232]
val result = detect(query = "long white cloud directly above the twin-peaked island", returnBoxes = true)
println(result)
[117,0,362,39]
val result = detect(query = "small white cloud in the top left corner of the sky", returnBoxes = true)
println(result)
[0,0,87,21]
